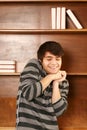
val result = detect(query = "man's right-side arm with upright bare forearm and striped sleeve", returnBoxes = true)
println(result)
[52,71,69,116]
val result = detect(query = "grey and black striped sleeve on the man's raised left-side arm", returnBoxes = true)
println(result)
[19,61,42,101]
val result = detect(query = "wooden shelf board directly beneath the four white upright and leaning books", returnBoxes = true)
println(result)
[0,29,87,34]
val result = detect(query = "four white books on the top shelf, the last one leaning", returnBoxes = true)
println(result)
[51,7,83,29]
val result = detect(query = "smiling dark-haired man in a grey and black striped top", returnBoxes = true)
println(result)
[16,41,69,130]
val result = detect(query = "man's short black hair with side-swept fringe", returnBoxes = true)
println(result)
[37,41,64,61]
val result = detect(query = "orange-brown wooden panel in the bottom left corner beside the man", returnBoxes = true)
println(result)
[0,97,16,127]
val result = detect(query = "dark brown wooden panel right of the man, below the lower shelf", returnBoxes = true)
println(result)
[58,76,87,130]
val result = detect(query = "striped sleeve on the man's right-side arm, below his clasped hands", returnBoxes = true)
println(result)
[53,80,69,117]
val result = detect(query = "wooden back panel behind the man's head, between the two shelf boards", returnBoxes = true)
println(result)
[0,33,87,73]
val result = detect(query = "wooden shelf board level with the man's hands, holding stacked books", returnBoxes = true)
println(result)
[0,72,87,76]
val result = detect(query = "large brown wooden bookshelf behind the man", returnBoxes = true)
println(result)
[0,0,87,130]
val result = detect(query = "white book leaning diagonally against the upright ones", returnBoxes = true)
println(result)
[66,9,83,29]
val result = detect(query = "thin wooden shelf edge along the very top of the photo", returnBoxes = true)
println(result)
[0,0,87,2]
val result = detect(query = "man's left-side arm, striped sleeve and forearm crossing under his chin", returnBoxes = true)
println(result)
[19,60,63,101]
